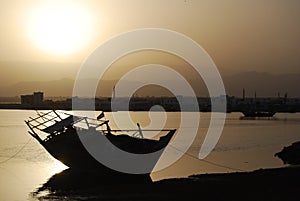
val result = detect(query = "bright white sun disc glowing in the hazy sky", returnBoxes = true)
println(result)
[28,1,92,55]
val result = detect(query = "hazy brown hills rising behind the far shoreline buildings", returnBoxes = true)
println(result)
[0,72,300,97]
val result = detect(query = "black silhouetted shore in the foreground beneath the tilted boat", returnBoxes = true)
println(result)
[33,166,300,201]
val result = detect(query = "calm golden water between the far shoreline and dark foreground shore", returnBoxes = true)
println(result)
[0,110,300,201]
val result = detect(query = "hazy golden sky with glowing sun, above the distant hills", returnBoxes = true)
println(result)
[0,0,300,89]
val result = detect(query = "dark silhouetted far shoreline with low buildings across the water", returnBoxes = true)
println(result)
[0,92,300,117]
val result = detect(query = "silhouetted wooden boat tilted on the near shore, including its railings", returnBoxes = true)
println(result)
[25,110,176,180]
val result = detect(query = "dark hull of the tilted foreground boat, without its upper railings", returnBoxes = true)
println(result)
[41,128,175,181]
